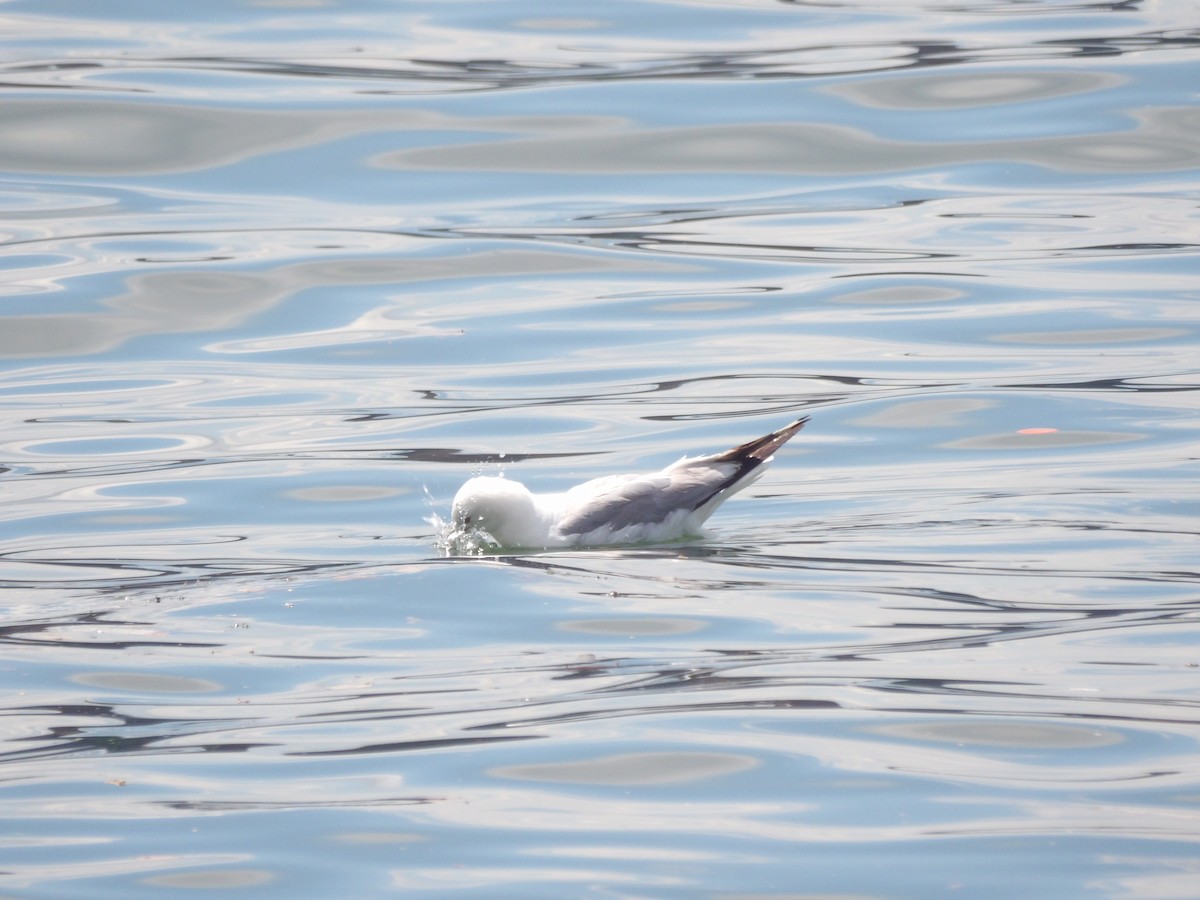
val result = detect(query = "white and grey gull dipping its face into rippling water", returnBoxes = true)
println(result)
[448,416,809,552]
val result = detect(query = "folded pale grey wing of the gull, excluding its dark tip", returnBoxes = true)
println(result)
[558,466,730,534]
